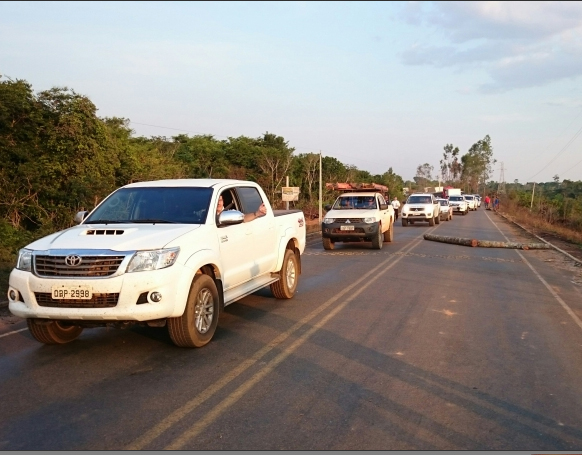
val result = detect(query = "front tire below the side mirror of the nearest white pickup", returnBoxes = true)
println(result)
[168,275,220,348]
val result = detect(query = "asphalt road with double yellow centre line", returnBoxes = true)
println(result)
[0,209,582,451]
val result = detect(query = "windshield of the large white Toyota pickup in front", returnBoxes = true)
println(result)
[84,187,212,224]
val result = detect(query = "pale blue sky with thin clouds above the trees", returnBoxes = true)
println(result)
[0,2,582,183]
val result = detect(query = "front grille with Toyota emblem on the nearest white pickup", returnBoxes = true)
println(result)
[34,255,125,278]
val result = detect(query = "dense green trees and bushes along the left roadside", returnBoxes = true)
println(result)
[0,77,403,288]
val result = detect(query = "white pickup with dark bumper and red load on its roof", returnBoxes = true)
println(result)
[321,191,394,250]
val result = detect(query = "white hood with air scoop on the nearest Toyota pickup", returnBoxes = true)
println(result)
[26,224,200,251]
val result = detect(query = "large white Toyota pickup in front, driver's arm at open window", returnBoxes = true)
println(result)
[8,179,306,347]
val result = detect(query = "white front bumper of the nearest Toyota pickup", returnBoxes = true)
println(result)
[8,264,194,321]
